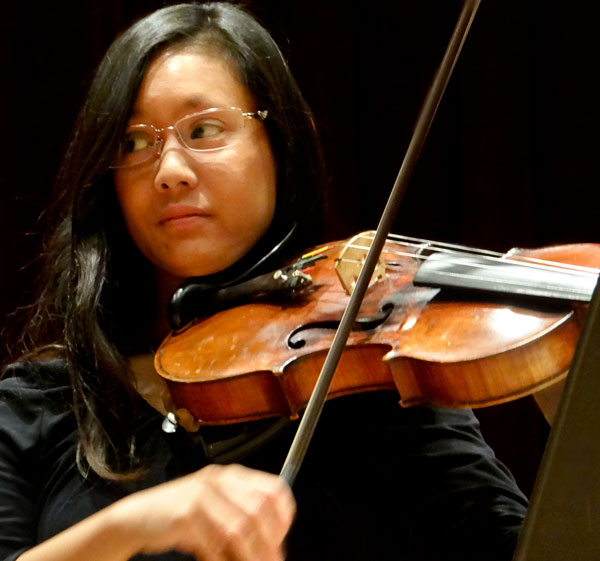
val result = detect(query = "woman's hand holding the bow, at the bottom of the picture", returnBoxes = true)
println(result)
[110,465,296,561]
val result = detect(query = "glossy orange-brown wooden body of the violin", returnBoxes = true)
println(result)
[155,235,600,424]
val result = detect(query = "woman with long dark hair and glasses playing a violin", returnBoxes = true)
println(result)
[0,3,526,561]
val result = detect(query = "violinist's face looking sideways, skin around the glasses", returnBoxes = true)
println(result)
[115,48,276,284]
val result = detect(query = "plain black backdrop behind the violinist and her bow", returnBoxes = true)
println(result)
[0,0,600,492]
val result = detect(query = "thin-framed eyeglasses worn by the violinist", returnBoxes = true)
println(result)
[112,107,268,168]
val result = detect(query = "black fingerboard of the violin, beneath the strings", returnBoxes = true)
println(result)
[413,253,598,302]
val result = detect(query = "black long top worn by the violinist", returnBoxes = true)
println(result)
[0,361,527,561]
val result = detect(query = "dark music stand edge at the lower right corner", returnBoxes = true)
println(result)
[513,272,600,561]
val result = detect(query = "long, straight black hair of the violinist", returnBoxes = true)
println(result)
[9,2,323,478]
